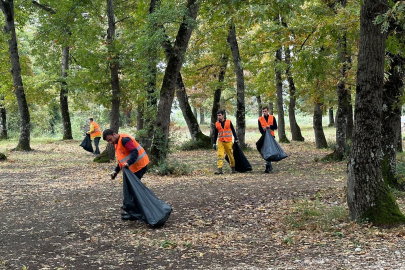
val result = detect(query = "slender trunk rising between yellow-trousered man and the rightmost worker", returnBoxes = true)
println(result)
[227,23,246,147]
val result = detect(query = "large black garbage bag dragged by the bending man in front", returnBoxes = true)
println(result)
[122,168,172,227]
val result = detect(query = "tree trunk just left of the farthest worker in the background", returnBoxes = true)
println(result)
[59,46,73,140]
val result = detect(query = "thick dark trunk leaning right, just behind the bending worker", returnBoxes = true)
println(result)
[150,0,198,164]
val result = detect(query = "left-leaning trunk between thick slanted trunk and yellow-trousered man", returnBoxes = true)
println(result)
[176,73,211,148]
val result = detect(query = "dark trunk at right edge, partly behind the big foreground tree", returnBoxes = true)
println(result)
[381,54,404,188]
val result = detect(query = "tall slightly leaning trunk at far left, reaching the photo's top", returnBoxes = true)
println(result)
[0,0,31,151]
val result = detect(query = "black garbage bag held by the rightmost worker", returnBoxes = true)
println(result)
[256,130,287,161]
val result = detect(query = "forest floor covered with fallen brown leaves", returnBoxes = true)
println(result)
[0,136,405,270]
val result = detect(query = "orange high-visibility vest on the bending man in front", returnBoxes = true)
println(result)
[115,133,149,173]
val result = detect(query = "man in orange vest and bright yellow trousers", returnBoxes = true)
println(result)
[213,111,238,174]
